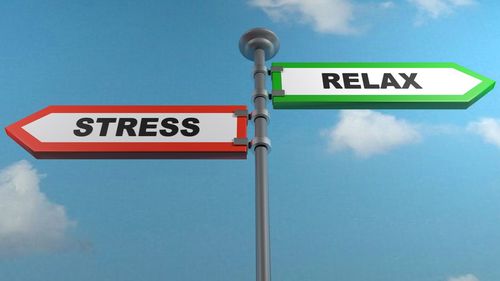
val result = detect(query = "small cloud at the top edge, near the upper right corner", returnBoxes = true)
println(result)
[408,0,476,24]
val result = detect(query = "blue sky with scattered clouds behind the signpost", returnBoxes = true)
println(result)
[0,0,500,281]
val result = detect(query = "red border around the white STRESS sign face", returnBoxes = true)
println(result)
[5,105,248,159]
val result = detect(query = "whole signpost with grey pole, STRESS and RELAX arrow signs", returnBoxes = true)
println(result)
[6,28,495,281]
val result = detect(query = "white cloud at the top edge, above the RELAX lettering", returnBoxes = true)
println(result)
[249,0,357,34]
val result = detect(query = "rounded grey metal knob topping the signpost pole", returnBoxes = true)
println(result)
[240,28,280,61]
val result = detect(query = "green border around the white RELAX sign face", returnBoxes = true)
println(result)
[271,62,495,109]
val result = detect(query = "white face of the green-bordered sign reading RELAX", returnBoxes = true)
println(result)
[281,68,481,95]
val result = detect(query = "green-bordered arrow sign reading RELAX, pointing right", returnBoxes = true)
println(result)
[271,63,495,109]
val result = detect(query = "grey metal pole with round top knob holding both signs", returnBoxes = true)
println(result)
[240,28,279,281]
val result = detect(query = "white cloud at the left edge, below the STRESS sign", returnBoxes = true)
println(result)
[0,161,75,256]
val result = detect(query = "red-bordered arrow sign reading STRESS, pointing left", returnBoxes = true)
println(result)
[6,105,248,159]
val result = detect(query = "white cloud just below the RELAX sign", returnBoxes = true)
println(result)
[324,110,421,157]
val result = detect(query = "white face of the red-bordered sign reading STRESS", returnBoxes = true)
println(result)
[22,113,238,143]
